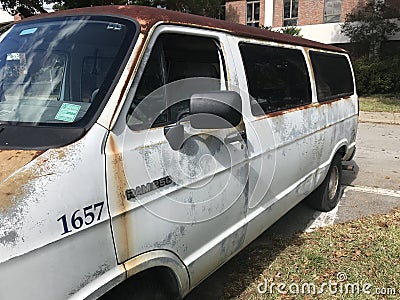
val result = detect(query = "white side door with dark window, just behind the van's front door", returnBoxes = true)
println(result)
[232,38,318,243]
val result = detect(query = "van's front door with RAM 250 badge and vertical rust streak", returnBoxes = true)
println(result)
[106,26,248,285]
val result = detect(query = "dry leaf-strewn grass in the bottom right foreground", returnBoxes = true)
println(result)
[224,210,400,300]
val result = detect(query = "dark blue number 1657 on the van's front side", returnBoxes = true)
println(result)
[57,201,104,235]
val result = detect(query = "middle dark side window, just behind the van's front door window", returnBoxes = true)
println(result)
[239,43,311,115]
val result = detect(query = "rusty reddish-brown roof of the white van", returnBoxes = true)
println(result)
[22,5,346,52]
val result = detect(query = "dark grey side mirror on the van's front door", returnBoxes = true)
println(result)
[189,91,242,129]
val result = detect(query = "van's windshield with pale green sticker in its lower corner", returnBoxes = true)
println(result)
[0,16,136,126]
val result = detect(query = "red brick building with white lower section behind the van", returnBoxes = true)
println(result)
[225,0,400,44]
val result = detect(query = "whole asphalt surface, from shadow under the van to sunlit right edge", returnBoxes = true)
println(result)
[185,123,400,300]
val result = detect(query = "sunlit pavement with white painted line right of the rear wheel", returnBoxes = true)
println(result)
[290,123,400,231]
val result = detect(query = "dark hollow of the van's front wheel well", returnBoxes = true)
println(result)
[100,267,180,300]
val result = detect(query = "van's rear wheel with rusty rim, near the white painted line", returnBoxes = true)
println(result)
[306,155,342,212]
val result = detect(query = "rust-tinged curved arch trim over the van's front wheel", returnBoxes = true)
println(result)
[123,250,190,296]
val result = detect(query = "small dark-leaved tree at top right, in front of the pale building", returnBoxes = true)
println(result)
[341,0,400,58]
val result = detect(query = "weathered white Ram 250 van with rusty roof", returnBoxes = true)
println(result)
[0,6,358,300]
